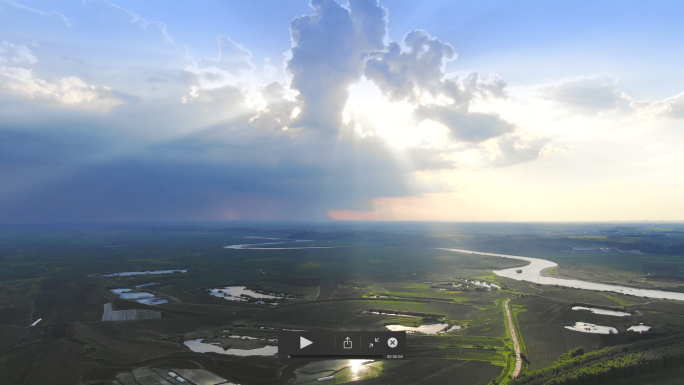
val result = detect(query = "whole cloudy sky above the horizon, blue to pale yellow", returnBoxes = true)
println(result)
[0,0,684,223]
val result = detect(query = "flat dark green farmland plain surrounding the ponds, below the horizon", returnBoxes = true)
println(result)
[0,224,684,385]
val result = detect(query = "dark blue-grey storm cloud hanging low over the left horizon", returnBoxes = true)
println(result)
[0,115,409,222]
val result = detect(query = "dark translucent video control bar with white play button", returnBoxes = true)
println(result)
[278,331,406,359]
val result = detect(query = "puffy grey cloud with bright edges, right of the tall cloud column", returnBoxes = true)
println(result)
[365,30,515,142]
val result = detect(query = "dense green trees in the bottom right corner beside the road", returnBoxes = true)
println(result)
[510,334,684,385]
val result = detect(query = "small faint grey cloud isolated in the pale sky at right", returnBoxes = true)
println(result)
[543,75,626,115]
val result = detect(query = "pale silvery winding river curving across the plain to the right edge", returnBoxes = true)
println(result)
[440,248,684,301]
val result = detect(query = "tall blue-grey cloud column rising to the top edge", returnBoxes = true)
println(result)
[287,0,387,129]
